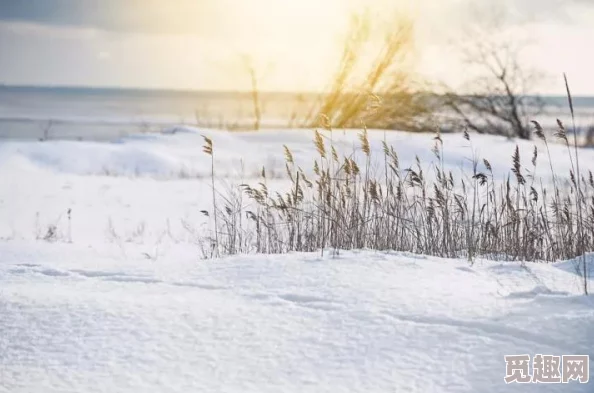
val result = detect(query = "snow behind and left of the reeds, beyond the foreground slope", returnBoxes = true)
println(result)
[0,127,594,244]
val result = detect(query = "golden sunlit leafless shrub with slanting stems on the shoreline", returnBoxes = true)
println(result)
[301,14,431,131]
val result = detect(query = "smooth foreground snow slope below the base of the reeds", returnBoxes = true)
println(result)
[0,242,594,392]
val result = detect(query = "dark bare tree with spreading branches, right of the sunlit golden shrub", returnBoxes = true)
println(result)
[445,21,544,139]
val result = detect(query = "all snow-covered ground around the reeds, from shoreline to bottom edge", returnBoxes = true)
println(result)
[0,129,594,392]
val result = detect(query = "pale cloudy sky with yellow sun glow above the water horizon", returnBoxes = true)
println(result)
[0,0,594,95]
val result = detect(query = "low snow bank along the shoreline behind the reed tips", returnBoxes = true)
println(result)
[0,126,594,179]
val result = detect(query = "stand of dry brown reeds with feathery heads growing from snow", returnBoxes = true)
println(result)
[201,118,594,291]
